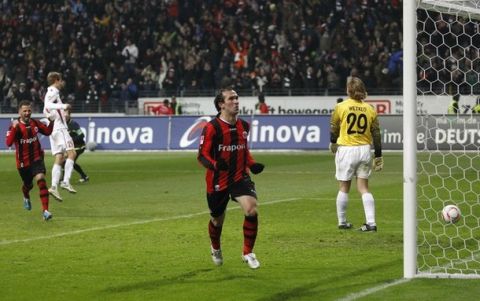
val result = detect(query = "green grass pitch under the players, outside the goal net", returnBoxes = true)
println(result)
[0,152,480,301]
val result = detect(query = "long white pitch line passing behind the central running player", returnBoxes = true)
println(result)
[0,198,300,246]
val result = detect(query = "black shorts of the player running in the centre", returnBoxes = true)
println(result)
[207,176,257,217]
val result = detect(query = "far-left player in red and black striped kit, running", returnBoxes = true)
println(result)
[6,101,54,221]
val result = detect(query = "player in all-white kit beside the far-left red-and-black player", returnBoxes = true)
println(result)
[43,72,76,201]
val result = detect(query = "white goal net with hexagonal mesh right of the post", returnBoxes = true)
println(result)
[416,0,480,278]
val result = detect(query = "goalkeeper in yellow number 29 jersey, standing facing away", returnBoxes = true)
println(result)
[330,77,383,232]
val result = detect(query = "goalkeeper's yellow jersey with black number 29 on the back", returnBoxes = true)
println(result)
[330,98,380,146]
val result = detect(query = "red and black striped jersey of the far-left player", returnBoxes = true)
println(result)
[6,119,54,168]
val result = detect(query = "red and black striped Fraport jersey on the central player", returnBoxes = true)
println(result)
[198,117,255,193]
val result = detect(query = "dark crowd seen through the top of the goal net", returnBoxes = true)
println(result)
[417,10,480,95]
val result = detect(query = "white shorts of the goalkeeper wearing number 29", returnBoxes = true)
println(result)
[335,145,372,181]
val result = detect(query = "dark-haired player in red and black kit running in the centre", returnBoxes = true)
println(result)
[198,88,264,269]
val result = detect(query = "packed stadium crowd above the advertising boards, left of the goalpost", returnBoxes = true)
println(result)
[0,0,402,112]
